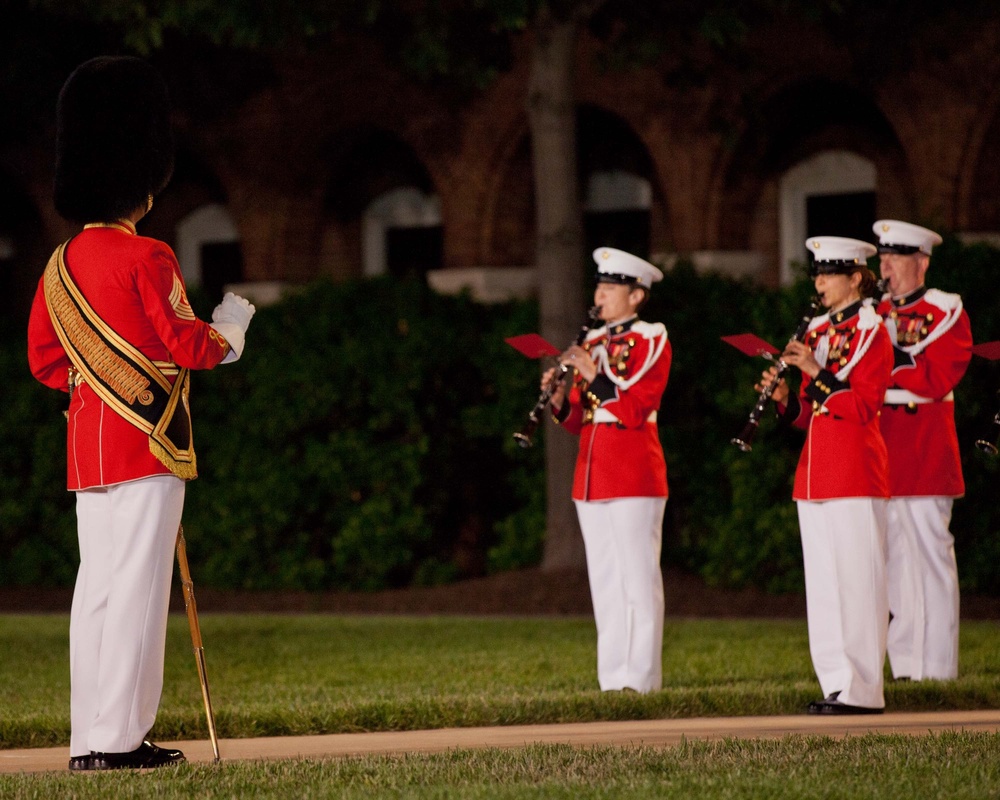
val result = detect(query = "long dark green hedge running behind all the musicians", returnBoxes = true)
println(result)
[0,240,1000,594]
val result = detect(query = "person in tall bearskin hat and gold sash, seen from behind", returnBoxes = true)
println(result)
[28,58,254,770]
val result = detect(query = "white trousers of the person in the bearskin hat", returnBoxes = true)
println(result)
[69,475,184,756]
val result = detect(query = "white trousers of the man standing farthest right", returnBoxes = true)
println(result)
[886,497,959,681]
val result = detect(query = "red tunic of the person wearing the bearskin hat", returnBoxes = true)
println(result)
[28,223,229,491]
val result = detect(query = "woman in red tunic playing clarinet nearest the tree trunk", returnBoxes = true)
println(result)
[542,247,671,692]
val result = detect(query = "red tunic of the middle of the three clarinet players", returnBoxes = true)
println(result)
[785,303,892,501]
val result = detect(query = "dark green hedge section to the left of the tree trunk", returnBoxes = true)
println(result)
[0,280,544,589]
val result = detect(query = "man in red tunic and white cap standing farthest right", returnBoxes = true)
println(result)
[873,219,972,680]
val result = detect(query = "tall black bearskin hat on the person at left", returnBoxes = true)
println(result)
[54,56,174,222]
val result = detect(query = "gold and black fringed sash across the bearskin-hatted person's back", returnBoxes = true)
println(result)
[43,242,198,480]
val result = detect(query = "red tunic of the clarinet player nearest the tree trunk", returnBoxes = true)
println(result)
[555,320,672,501]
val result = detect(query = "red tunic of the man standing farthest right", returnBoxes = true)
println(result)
[878,287,972,497]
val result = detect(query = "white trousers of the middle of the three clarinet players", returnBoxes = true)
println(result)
[798,497,889,708]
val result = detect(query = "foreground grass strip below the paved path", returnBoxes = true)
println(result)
[0,733,1000,800]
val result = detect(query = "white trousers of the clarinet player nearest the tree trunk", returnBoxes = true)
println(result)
[576,497,667,692]
